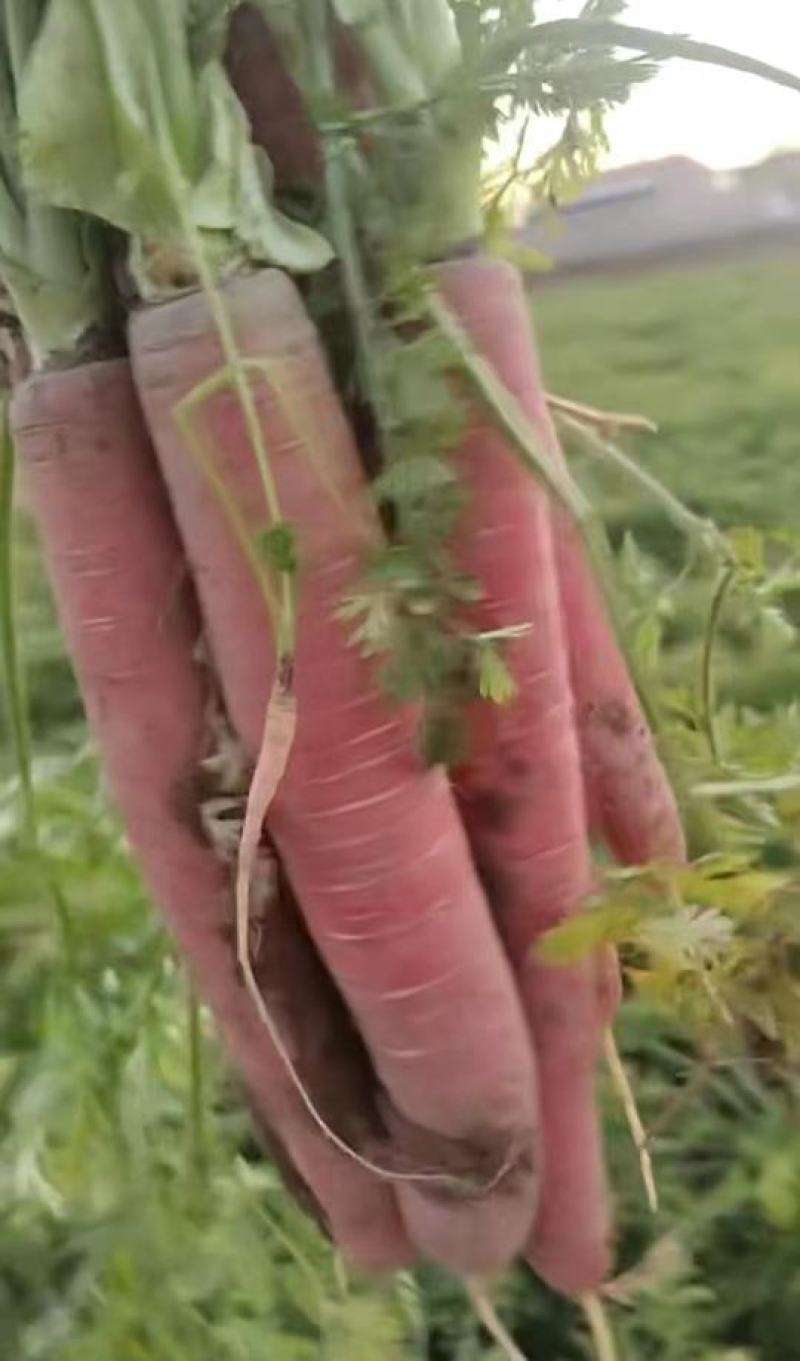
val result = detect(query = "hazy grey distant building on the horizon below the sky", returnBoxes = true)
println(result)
[522,152,800,272]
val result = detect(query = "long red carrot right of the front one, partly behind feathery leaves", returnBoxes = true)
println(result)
[433,256,610,1292]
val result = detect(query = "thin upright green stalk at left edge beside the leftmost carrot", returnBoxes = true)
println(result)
[0,399,38,851]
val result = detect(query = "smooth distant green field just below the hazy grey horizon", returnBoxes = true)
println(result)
[535,257,800,542]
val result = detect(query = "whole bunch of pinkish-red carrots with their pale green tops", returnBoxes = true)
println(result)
[0,0,794,1350]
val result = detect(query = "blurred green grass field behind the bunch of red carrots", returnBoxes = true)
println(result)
[0,250,800,1361]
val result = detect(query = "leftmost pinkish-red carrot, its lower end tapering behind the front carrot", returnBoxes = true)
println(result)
[12,361,411,1270]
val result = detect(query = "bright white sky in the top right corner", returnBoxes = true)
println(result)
[536,0,800,169]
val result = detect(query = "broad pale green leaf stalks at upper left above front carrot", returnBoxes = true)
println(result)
[20,0,331,295]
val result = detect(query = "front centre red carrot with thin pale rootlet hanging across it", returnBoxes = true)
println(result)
[131,271,535,1271]
